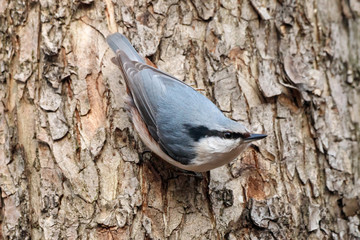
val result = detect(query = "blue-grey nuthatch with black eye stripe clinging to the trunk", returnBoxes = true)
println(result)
[106,33,267,172]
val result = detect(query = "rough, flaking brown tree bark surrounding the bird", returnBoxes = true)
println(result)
[0,0,360,239]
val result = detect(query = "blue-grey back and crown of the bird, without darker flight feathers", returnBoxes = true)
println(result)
[135,69,228,164]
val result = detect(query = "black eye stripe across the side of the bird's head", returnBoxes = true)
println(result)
[184,124,246,142]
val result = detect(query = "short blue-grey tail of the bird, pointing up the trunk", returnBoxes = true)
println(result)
[106,33,145,63]
